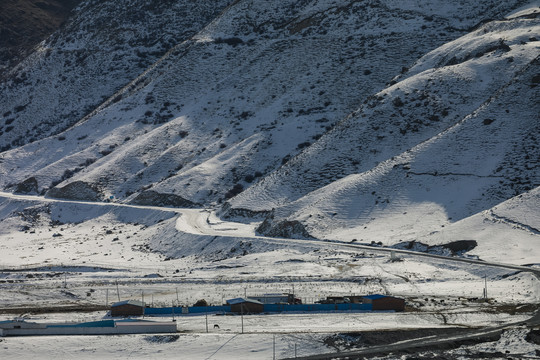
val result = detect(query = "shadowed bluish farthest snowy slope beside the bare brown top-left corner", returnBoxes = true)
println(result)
[0,0,234,151]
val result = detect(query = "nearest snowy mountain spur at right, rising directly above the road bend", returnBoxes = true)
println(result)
[231,9,540,252]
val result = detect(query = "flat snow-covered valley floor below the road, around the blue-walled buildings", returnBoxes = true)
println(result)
[0,194,540,359]
